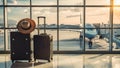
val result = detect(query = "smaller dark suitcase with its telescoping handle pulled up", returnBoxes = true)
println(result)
[34,17,53,62]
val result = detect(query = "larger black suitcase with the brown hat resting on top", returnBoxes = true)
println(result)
[10,32,31,62]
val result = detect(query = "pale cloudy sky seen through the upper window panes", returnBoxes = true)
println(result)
[0,0,120,24]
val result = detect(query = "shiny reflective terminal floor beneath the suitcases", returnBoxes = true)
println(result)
[0,54,120,68]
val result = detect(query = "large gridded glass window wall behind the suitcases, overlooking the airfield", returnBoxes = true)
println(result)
[0,0,120,52]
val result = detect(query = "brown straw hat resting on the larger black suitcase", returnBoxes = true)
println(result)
[17,18,36,34]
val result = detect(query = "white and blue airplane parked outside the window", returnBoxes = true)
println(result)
[67,14,98,49]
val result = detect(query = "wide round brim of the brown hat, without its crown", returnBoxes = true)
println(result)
[17,18,36,34]
